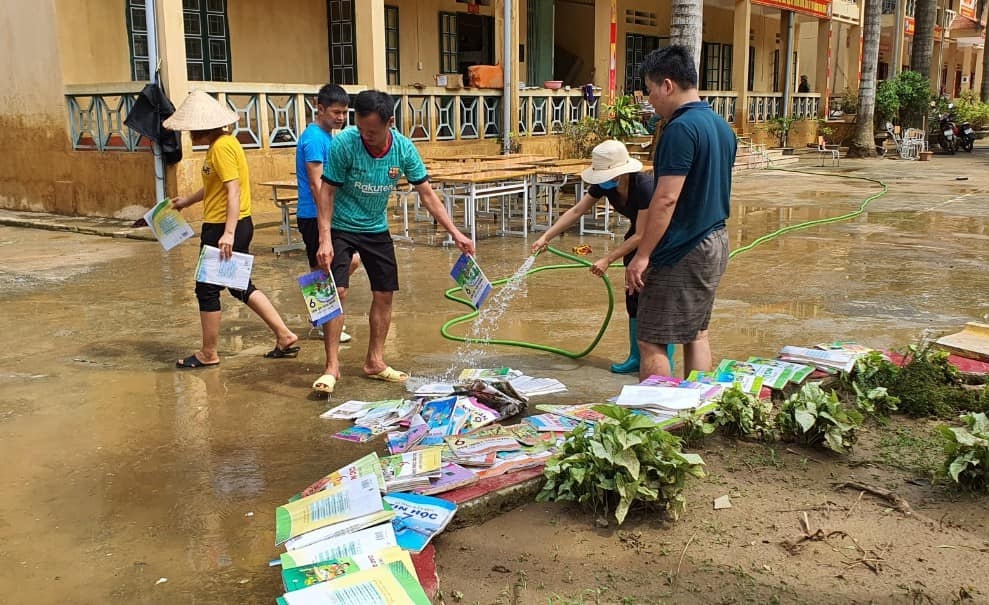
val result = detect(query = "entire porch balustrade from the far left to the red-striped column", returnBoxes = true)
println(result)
[65,82,600,151]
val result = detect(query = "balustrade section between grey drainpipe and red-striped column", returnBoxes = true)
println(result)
[518,88,601,136]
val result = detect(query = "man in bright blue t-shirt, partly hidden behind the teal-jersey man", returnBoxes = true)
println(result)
[295,84,360,358]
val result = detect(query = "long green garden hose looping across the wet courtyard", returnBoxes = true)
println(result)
[440,168,889,359]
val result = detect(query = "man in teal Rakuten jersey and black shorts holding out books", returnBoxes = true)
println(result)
[313,90,474,393]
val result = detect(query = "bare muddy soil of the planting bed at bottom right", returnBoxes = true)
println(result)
[437,416,989,605]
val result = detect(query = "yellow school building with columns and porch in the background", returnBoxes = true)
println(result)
[0,0,984,218]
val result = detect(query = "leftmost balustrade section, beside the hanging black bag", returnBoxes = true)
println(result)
[65,82,151,151]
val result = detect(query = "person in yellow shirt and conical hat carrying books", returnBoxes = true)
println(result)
[164,90,299,368]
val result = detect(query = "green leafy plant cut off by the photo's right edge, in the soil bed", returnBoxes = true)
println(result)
[938,412,989,490]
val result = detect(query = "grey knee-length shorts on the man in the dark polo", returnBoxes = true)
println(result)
[637,229,728,345]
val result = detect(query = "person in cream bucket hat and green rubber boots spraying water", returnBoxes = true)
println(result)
[532,140,673,374]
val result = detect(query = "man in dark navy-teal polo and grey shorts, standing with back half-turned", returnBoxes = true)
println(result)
[625,45,737,379]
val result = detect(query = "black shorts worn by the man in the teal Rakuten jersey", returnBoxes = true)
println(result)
[330,230,398,292]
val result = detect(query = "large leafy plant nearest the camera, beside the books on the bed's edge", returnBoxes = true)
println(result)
[536,405,704,525]
